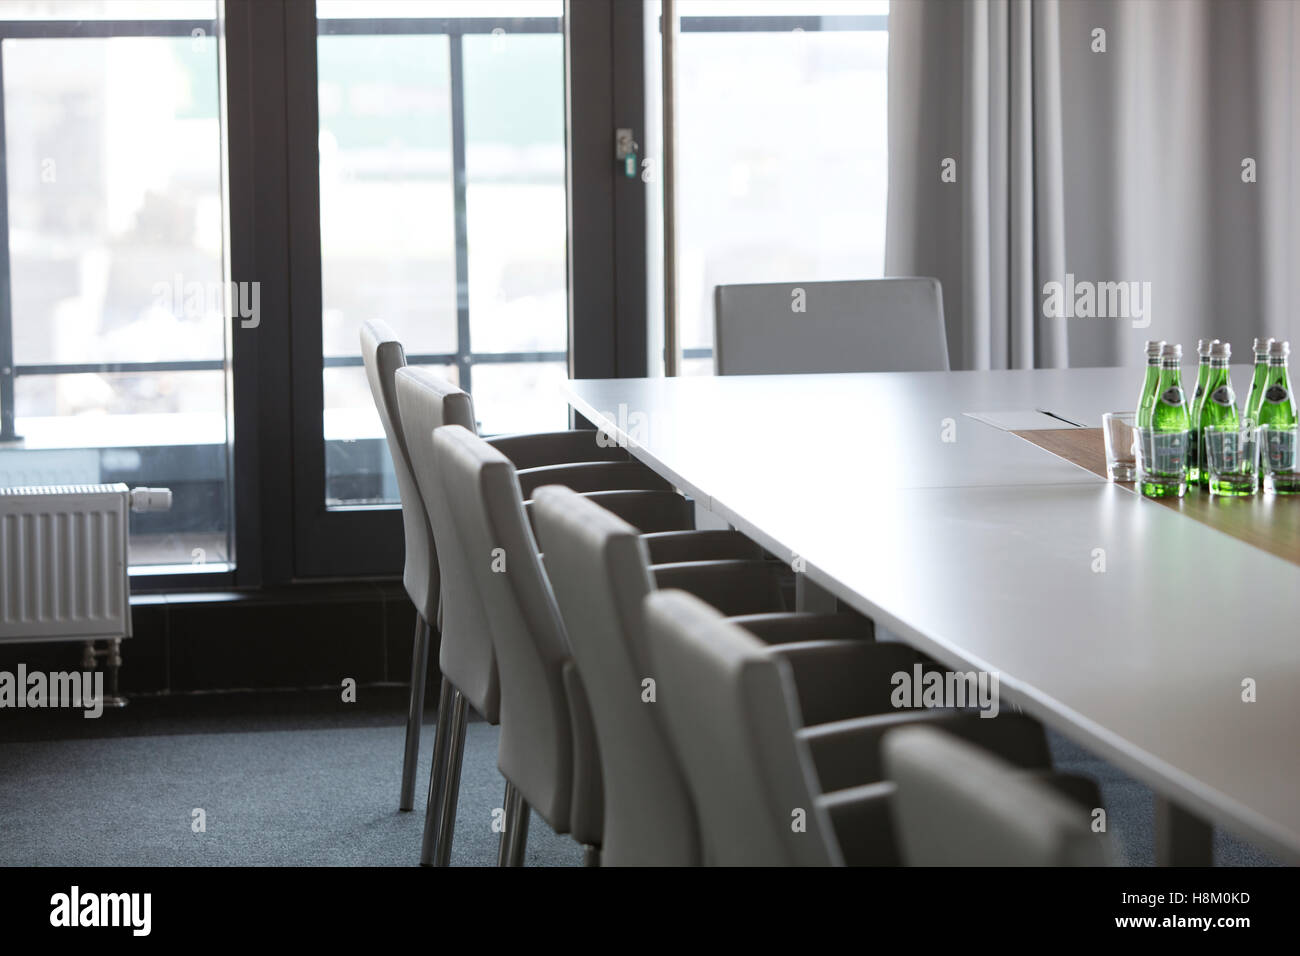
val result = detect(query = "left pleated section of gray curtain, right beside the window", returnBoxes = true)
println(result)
[885,0,1067,368]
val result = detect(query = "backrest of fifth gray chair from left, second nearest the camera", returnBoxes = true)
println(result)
[645,591,844,866]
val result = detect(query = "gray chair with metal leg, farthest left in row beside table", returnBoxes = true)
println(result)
[361,321,439,810]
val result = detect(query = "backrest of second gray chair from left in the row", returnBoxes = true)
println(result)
[397,365,501,723]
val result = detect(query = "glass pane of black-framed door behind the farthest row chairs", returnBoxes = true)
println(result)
[317,9,568,507]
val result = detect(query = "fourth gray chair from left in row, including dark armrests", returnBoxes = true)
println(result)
[533,486,873,866]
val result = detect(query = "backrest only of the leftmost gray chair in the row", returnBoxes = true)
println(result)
[361,321,439,624]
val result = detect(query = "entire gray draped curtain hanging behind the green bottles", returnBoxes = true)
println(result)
[885,0,1300,368]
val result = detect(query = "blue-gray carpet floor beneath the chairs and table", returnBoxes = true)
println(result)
[0,714,1275,866]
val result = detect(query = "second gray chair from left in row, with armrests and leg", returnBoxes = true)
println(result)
[384,367,761,865]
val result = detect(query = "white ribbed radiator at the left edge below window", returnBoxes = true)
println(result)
[0,484,172,643]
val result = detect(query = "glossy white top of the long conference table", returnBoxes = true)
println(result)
[567,368,1300,865]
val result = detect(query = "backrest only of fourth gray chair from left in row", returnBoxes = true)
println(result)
[533,485,699,866]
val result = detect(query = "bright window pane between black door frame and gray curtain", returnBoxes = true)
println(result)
[646,0,888,369]
